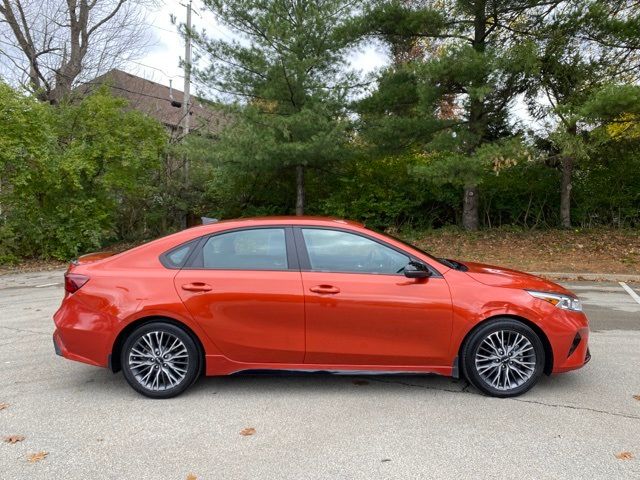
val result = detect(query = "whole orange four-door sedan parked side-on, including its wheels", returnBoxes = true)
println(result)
[53,217,590,398]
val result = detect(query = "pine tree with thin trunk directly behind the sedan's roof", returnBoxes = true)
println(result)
[192,0,360,215]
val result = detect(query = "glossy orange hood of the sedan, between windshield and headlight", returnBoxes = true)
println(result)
[462,262,572,295]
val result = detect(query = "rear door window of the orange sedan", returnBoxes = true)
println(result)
[202,228,288,270]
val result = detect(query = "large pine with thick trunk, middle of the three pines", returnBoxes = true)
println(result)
[359,0,562,230]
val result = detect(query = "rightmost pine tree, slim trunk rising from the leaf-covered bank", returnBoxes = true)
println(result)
[528,0,640,228]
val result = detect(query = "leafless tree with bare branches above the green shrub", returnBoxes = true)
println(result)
[0,0,156,103]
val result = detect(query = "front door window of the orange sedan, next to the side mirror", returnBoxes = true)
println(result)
[302,228,410,273]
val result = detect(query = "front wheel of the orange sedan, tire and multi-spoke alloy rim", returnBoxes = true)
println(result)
[462,318,545,398]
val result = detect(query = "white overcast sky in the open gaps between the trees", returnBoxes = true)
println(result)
[134,0,389,98]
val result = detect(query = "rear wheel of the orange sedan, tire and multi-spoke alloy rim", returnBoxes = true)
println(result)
[120,321,202,399]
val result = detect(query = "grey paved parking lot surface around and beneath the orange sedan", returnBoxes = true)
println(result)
[0,271,640,479]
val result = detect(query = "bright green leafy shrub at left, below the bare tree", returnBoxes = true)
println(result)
[0,85,167,262]
